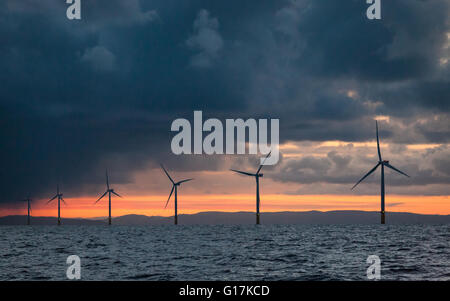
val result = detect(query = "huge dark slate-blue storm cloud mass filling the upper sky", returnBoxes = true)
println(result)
[0,0,450,201]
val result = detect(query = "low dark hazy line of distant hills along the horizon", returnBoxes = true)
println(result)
[0,211,450,225]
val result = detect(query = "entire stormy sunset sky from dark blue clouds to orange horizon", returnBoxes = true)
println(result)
[0,0,450,217]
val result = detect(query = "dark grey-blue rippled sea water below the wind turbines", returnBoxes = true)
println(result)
[0,225,450,280]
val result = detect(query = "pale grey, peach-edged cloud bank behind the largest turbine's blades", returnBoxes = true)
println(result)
[267,140,450,193]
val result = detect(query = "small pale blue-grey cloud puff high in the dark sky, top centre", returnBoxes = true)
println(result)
[186,9,223,68]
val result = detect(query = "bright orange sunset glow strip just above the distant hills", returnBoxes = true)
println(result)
[0,194,450,218]
